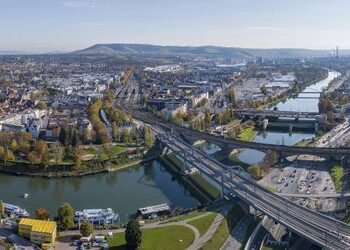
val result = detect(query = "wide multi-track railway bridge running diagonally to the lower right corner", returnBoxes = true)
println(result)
[152,126,350,249]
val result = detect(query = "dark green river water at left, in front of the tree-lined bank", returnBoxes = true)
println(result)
[0,161,200,221]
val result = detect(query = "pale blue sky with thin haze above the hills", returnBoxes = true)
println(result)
[0,0,350,52]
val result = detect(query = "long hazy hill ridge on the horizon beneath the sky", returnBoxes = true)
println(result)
[74,44,340,58]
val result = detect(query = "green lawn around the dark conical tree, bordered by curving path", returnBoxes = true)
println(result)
[108,226,194,250]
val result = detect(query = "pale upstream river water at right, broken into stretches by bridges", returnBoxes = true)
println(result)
[237,71,339,165]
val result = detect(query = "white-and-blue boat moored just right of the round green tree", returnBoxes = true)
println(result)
[74,208,118,224]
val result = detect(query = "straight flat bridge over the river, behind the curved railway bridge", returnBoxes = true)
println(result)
[234,109,320,119]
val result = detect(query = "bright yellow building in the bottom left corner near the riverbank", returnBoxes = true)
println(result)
[18,218,57,249]
